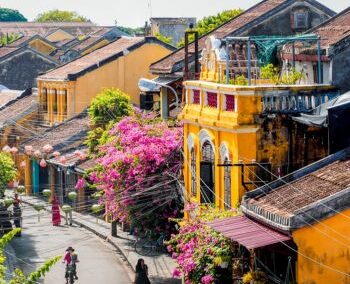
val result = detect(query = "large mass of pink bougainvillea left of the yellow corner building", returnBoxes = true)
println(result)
[82,110,182,234]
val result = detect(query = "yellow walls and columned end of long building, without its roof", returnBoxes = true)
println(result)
[38,43,171,123]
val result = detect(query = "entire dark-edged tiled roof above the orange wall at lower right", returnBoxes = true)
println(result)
[242,149,350,231]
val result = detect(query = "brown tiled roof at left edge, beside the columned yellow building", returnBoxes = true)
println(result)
[0,92,38,127]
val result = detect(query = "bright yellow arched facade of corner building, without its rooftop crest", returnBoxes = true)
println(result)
[179,81,334,209]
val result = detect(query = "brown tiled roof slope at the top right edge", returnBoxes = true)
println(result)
[312,7,350,48]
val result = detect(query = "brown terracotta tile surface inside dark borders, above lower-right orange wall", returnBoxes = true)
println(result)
[247,159,350,217]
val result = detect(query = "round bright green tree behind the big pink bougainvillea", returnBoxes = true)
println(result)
[85,88,132,153]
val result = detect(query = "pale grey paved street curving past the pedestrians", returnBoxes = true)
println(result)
[11,205,133,284]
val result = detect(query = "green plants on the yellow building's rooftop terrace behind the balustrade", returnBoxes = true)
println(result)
[261,64,304,85]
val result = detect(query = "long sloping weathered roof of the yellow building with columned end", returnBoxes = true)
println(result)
[38,37,145,80]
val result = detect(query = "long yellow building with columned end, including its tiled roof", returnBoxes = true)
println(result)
[37,37,172,122]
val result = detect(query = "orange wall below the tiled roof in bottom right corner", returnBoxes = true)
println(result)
[293,209,350,284]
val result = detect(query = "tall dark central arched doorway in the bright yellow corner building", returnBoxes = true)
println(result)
[200,141,215,204]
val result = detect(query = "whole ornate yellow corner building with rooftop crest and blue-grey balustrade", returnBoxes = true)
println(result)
[179,36,338,209]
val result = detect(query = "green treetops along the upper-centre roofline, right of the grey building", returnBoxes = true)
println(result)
[178,9,243,47]
